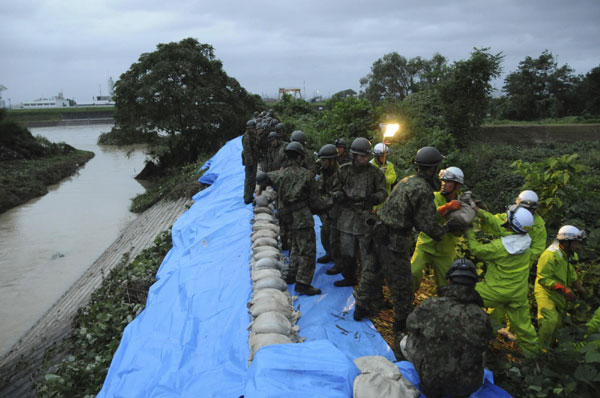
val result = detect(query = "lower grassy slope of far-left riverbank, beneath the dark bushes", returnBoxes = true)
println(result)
[0,150,94,213]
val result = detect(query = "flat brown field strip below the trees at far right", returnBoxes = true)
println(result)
[473,124,600,146]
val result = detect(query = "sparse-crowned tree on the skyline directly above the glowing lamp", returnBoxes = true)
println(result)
[360,52,446,102]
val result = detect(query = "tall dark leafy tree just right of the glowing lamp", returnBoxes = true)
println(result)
[438,48,503,136]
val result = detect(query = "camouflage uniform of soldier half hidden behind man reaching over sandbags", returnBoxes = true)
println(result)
[319,162,340,261]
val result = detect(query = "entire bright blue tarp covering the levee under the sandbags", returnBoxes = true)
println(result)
[98,137,510,398]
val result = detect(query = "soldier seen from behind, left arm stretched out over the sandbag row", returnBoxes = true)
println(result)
[258,142,321,296]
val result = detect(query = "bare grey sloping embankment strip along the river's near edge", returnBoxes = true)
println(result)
[0,199,188,397]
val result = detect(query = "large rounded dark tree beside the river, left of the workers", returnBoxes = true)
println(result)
[113,38,261,166]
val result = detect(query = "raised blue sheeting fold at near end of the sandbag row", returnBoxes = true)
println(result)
[245,340,359,398]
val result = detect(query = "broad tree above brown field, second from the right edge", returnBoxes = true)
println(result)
[503,50,578,120]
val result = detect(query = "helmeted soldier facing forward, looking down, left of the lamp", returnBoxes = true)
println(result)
[332,137,387,292]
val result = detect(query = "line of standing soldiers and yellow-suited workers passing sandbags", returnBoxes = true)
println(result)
[242,111,600,380]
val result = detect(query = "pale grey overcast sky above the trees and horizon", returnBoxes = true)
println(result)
[0,0,600,105]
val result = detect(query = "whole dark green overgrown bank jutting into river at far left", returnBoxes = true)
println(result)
[0,110,94,213]
